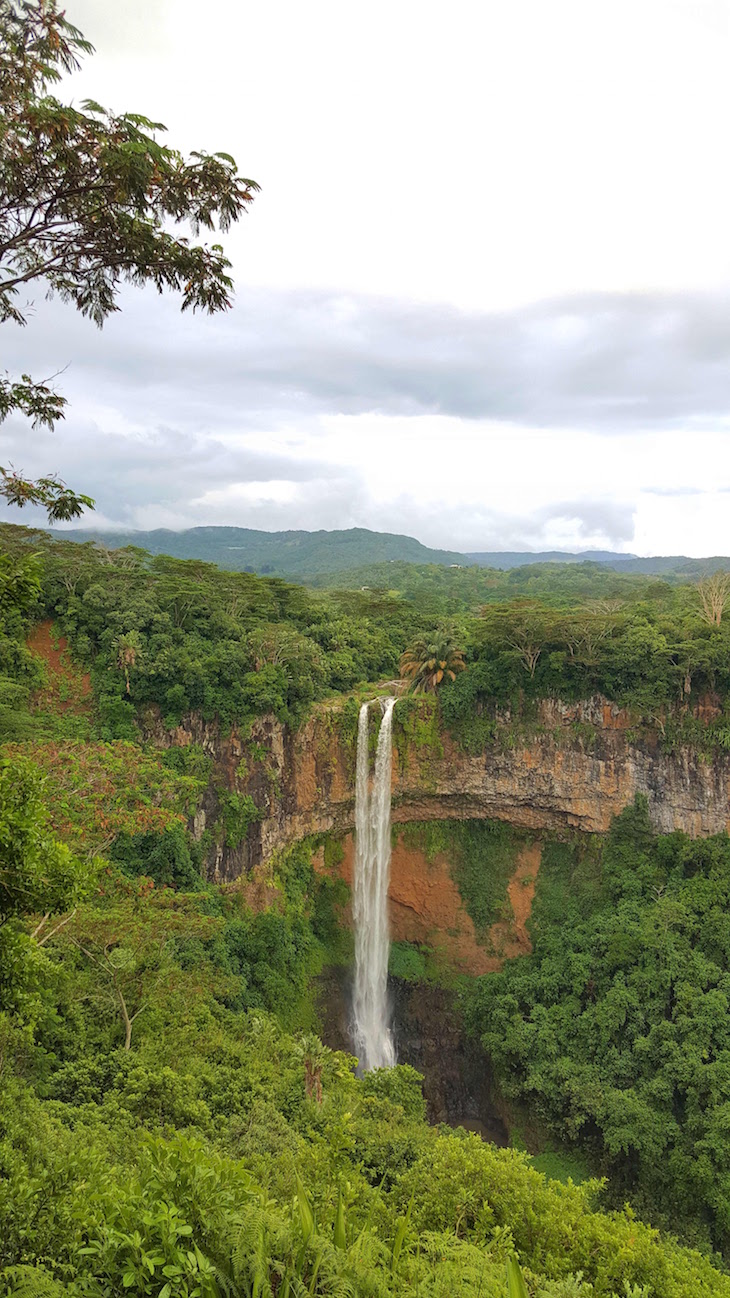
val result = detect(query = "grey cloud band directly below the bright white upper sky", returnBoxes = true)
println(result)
[4,288,730,432]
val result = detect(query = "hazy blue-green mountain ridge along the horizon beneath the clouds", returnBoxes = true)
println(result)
[52,527,730,579]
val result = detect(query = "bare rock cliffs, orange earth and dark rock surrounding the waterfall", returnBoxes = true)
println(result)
[137,696,730,1126]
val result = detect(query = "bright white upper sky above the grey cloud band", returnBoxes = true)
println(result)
[61,0,730,309]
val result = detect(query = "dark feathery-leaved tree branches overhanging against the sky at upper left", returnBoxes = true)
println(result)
[0,0,258,522]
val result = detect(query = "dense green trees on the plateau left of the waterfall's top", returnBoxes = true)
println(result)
[0,526,422,740]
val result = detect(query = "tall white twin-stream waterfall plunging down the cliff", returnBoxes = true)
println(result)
[353,698,395,1072]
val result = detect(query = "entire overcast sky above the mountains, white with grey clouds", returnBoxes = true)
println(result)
[0,0,730,554]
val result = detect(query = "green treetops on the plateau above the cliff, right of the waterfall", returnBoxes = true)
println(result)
[440,581,730,750]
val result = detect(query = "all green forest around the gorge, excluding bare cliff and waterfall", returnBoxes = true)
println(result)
[0,527,730,1298]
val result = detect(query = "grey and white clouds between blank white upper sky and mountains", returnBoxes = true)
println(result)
[0,289,730,549]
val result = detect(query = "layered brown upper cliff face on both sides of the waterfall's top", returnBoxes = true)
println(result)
[147,697,730,881]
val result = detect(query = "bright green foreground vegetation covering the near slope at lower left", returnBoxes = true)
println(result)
[0,783,730,1298]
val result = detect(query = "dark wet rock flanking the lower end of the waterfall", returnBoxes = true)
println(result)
[317,968,509,1146]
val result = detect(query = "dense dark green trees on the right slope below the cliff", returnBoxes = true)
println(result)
[468,800,730,1251]
